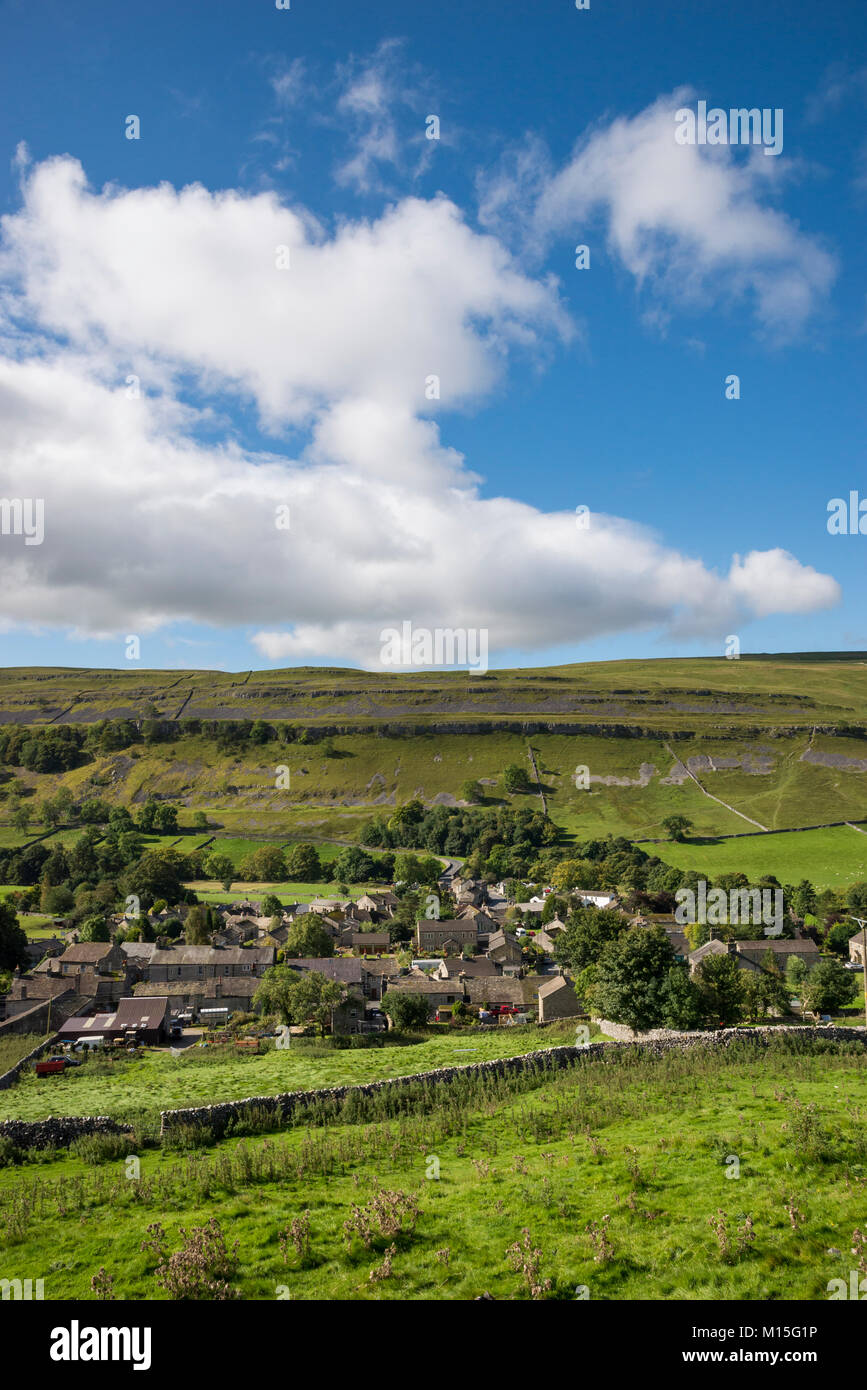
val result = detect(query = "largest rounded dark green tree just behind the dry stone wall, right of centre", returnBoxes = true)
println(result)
[591,927,677,1030]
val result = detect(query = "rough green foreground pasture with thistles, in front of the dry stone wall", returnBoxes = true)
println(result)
[0,1043,867,1302]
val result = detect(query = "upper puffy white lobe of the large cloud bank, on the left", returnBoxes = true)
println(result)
[0,158,572,423]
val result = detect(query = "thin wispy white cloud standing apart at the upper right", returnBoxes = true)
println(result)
[479,88,835,341]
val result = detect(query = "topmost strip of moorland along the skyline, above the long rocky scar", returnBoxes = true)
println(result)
[0,652,867,727]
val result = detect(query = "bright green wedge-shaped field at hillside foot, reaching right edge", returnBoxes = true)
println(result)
[642,826,867,888]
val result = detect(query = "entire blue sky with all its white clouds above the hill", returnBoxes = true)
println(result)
[0,0,867,669]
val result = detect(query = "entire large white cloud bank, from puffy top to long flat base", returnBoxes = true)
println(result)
[0,158,838,669]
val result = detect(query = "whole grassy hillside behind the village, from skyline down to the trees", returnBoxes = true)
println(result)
[0,652,867,858]
